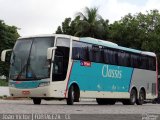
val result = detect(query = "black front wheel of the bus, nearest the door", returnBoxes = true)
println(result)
[67,85,75,105]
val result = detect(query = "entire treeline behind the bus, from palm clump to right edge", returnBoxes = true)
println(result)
[56,7,160,53]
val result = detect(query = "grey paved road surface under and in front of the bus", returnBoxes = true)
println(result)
[0,100,160,120]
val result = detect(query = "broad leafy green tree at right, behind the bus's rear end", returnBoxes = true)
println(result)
[110,10,160,52]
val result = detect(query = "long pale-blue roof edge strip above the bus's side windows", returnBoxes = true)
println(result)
[80,37,156,56]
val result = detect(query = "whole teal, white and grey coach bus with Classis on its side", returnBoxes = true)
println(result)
[1,34,158,105]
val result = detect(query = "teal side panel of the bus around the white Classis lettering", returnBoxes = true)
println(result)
[68,60,133,92]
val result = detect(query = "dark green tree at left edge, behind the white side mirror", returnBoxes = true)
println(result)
[0,20,19,76]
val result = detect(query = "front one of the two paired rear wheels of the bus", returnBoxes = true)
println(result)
[122,89,137,105]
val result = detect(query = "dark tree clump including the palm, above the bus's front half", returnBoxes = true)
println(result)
[56,7,109,40]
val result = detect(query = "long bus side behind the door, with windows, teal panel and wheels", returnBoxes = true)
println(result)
[65,40,157,105]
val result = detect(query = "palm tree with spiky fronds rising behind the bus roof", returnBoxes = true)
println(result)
[75,7,104,38]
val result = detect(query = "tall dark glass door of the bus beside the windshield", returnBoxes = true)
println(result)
[52,37,70,82]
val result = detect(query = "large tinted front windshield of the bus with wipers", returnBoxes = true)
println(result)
[10,37,54,81]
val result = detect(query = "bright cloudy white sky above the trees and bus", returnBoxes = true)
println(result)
[0,0,160,36]
